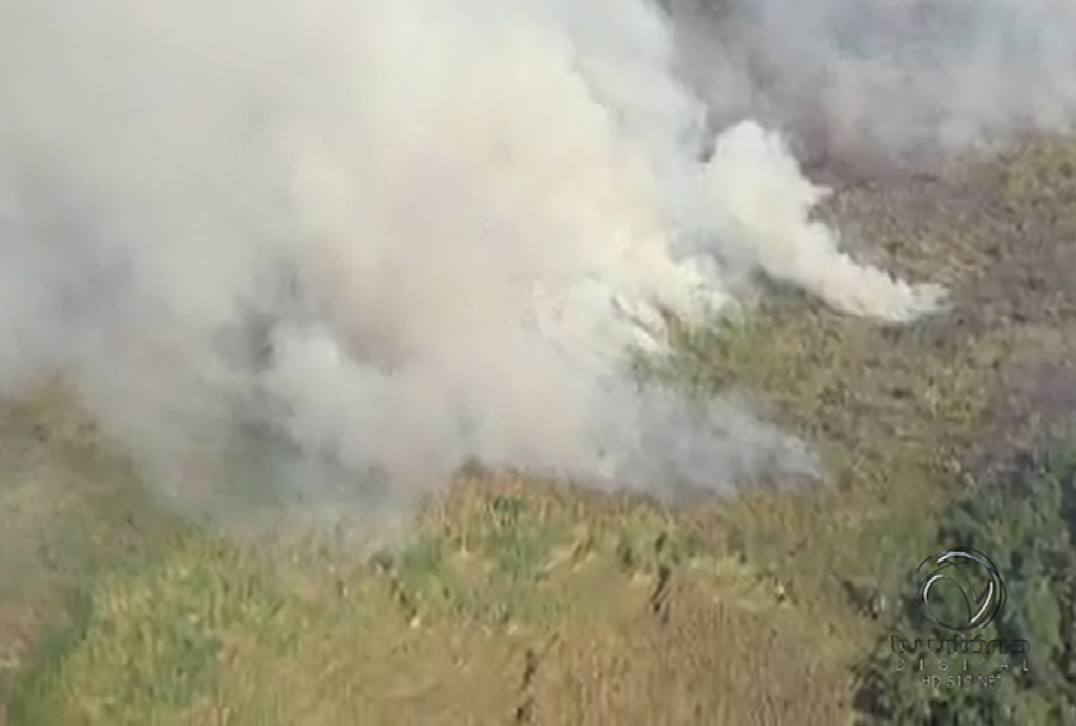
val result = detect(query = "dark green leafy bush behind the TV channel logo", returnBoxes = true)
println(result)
[856,449,1076,726]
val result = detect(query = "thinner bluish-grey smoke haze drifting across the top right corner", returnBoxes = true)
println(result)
[666,0,1076,166]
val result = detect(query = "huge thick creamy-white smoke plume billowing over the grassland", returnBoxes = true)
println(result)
[0,0,955,522]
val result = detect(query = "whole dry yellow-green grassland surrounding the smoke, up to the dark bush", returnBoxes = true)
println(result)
[0,134,1076,726]
